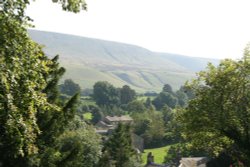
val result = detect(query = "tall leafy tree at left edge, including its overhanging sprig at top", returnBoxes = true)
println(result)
[0,0,85,167]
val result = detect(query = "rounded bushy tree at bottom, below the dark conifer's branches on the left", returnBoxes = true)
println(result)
[42,117,101,167]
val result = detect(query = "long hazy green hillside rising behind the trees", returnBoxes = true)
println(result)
[29,30,219,92]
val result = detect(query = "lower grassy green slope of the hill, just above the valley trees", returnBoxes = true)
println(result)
[61,60,194,93]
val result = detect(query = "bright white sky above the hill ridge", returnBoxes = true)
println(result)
[27,0,250,59]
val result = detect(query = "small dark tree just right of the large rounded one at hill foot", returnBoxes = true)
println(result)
[120,85,136,104]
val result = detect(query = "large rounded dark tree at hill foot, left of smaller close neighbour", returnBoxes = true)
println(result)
[93,81,120,106]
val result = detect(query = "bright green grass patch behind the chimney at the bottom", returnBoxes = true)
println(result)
[142,145,170,164]
